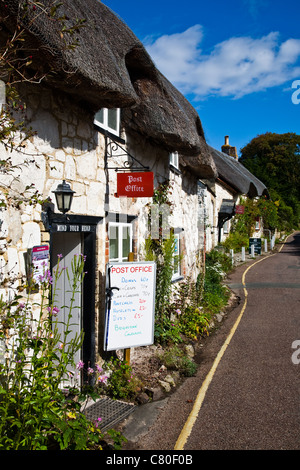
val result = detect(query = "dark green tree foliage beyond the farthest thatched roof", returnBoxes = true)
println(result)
[240,132,300,229]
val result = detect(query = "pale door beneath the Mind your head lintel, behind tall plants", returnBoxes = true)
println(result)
[52,233,82,384]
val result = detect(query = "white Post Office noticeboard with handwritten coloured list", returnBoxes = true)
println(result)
[104,262,156,351]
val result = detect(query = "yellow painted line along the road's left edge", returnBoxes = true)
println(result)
[174,238,287,450]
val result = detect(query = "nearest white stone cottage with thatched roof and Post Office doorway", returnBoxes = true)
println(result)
[0,0,217,364]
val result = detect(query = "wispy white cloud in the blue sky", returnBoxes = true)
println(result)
[145,25,300,99]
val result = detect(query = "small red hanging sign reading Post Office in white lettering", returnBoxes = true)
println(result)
[117,171,154,197]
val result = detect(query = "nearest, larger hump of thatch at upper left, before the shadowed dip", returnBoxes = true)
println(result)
[0,0,145,110]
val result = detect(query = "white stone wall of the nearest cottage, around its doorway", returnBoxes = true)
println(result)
[0,82,206,360]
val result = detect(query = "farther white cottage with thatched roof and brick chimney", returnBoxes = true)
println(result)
[202,136,269,251]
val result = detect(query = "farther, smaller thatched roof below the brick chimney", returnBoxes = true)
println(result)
[209,146,269,197]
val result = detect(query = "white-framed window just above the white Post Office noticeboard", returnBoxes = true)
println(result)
[109,222,132,263]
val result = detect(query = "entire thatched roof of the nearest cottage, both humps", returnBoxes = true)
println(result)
[0,0,215,177]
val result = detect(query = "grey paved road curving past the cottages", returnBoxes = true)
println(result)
[132,233,300,450]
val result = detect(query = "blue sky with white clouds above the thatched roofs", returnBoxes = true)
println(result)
[103,0,300,153]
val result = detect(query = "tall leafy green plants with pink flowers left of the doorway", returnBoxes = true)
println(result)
[0,256,102,450]
